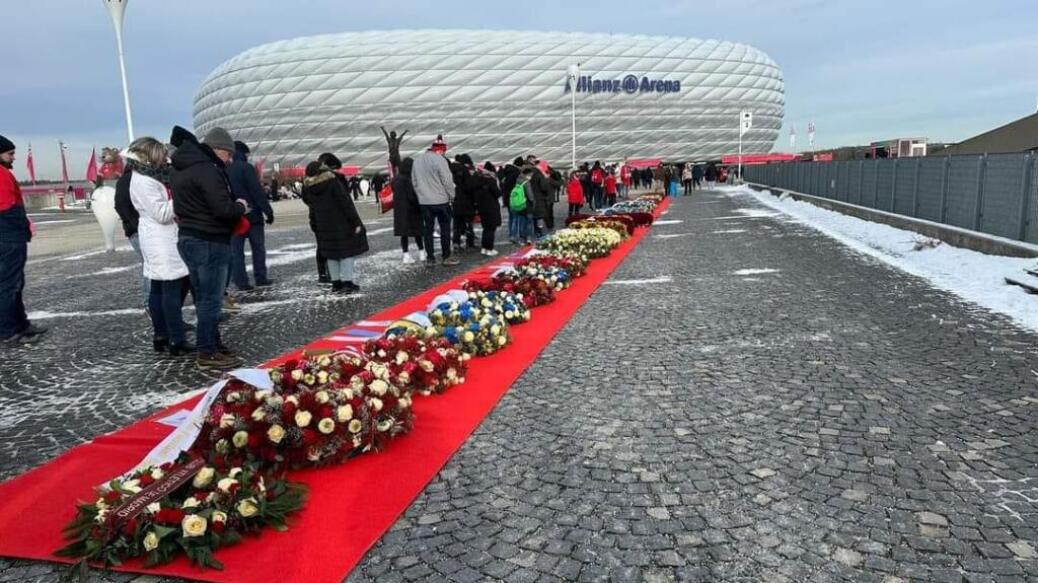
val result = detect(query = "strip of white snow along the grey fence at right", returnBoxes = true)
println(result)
[721,186,1038,331]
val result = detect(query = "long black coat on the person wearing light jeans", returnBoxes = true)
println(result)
[303,171,367,259]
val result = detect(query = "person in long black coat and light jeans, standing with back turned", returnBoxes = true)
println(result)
[303,162,368,294]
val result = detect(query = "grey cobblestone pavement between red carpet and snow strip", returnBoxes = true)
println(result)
[0,192,1038,583]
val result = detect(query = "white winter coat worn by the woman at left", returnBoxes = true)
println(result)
[130,172,188,281]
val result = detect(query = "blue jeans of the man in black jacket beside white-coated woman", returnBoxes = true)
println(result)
[176,233,230,354]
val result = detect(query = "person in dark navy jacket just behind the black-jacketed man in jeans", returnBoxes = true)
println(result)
[227,142,274,292]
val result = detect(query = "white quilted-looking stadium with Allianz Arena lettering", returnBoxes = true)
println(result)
[194,30,785,171]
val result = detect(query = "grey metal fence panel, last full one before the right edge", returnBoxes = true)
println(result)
[980,154,1029,239]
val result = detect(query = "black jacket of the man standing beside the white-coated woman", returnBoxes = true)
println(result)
[170,139,245,244]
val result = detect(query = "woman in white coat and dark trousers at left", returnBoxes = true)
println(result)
[127,138,193,356]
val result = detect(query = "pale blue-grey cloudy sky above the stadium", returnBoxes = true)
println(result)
[0,0,1038,178]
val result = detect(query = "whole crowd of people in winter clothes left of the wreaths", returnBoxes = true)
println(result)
[0,127,739,368]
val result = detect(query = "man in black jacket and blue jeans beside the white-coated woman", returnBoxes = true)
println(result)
[170,127,249,368]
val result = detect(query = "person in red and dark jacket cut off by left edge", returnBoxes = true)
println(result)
[0,136,47,348]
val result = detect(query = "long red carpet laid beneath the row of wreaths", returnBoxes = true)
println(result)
[0,199,670,583]
